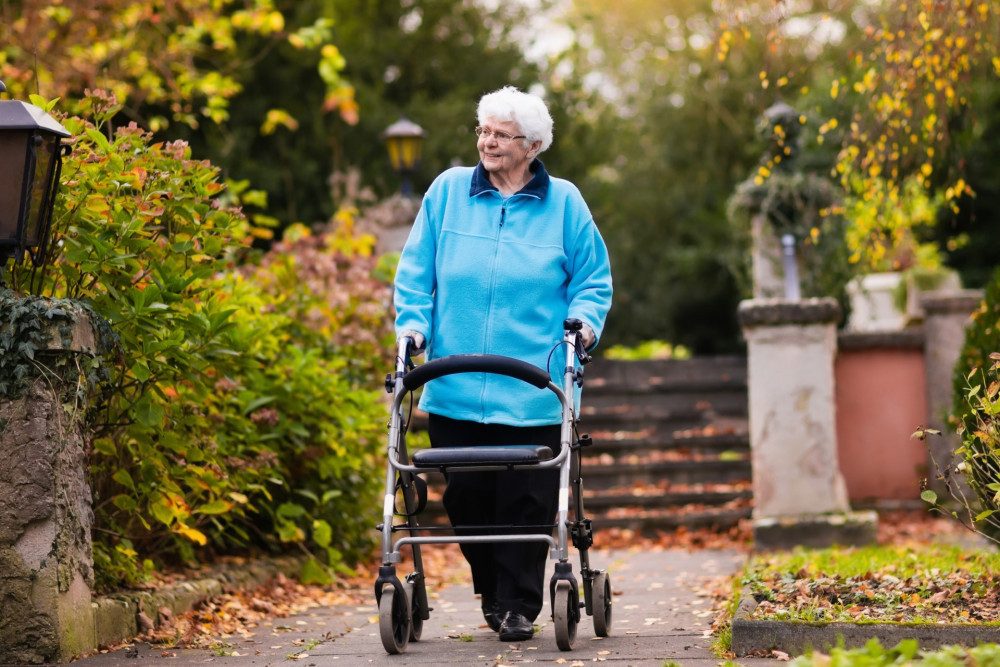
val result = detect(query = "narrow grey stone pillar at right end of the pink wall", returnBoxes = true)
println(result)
[920,290,983,493]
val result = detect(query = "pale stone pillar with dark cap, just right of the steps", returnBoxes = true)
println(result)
[738,298,877,549]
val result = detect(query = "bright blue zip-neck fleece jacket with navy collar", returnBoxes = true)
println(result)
[395,160,612,426]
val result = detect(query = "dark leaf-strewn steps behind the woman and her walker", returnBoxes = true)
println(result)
[412,356,753,533]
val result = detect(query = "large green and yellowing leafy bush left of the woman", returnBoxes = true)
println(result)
[10,93,391,587]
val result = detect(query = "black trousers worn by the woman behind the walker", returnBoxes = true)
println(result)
[428,414,560,621]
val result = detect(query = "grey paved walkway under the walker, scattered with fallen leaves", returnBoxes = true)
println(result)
[74,550,775,667]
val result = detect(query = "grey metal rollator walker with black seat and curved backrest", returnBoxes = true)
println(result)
[375,319,612,654]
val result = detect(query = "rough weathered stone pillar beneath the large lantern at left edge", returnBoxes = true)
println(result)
[0,316,95,664]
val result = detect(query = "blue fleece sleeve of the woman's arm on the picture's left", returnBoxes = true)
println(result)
[393,199,437,343]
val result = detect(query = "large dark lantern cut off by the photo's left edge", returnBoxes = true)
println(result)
[0,82,71,268]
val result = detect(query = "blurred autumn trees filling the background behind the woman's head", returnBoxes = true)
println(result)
[0,0,1000,354]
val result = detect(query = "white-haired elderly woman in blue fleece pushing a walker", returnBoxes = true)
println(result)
[395,86,612,641]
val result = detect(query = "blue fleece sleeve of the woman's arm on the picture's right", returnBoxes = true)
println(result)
[567,218,612,347]
